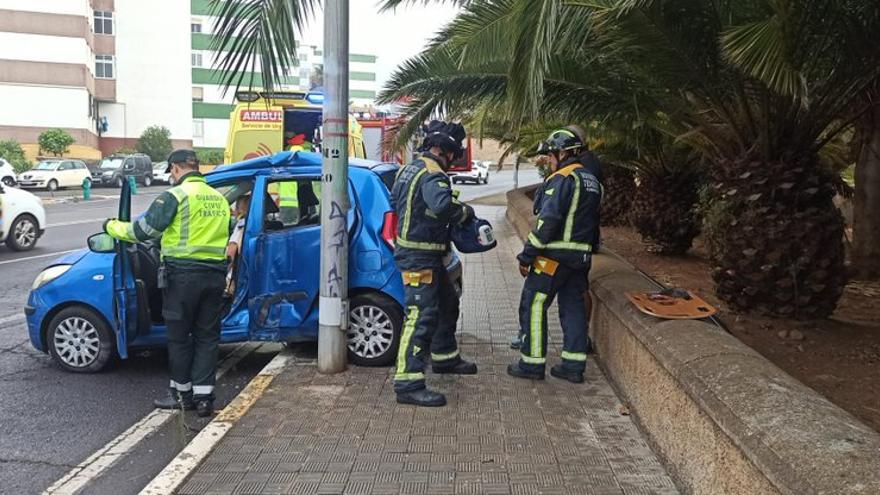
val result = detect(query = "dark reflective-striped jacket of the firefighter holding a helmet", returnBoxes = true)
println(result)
[391,153,474,259]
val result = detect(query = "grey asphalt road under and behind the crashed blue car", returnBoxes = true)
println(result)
[0,169,539,494]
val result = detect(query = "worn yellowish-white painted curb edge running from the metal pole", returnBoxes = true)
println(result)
[140,349,295,495]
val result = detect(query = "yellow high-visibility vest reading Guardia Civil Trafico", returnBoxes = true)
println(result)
[162,176,230,261]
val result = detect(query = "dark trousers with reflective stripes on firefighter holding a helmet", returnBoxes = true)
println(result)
[394,258,461,393]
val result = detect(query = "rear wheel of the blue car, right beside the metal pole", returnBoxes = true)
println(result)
[348,292,403,366]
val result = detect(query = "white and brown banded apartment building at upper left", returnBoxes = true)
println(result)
[0,0,192,159]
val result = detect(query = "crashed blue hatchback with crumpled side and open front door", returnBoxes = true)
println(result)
[25,152,461,372]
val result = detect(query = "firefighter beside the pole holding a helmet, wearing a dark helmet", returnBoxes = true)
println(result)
[391,121,477,407]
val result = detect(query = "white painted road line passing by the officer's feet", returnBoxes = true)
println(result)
[43,344,262,495]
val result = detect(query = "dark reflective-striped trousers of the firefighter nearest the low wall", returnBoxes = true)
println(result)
[519,257,590,373]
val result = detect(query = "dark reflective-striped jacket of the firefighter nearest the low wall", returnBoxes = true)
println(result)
[517,154,602,269]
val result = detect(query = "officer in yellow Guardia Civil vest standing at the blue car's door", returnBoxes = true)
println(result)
[104,150,230,417]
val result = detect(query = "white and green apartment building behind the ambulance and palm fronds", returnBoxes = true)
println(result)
[189,0,378,149]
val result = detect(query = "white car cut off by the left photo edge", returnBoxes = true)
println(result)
[0,185,46,251]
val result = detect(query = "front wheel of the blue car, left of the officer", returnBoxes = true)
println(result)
[46,306,116,373]
